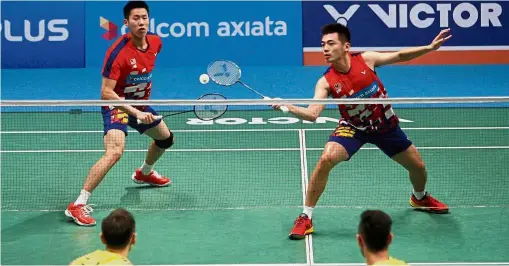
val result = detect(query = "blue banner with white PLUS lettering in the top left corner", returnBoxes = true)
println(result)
[0,1,85,68]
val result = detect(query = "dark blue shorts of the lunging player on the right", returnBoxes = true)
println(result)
[329,124,412,161]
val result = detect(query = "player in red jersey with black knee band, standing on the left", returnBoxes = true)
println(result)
[65,1,173,226]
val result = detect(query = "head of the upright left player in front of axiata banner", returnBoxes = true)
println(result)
[124,1,149,38]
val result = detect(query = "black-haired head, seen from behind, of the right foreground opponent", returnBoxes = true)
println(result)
[357,210,393,256]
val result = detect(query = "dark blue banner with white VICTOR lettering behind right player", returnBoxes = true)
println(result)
[303,1,509,50]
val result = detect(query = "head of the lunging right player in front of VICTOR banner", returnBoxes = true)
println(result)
[322,23,350,63]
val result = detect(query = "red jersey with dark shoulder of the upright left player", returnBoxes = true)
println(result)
[102,33,162,103]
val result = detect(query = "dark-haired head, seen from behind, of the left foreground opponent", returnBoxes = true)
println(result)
[100,208,136,250]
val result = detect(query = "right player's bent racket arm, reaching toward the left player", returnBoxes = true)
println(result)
[272,77,329,121]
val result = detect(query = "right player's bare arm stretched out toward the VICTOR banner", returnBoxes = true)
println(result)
[362,29,452,69]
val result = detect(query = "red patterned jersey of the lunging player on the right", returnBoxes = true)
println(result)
[324,53,399,132]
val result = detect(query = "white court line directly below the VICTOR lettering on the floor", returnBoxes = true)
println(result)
[0,127,509,134]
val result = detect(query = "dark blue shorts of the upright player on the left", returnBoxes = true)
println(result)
[101,106,161,136]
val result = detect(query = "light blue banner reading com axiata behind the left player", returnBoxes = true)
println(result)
[86,1,302,67]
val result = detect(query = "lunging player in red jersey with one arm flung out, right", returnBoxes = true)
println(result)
[273,24,452,239]
